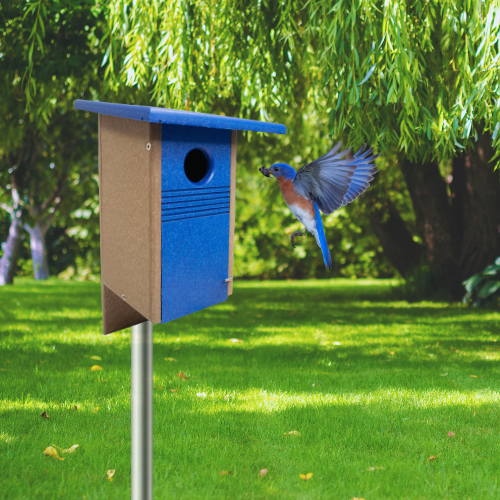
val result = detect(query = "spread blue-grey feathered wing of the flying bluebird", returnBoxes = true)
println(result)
[293,142,380,215]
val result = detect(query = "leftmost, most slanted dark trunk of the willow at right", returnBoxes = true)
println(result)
[369,200,423,278]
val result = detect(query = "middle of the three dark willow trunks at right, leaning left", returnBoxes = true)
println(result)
[400,154,463,299]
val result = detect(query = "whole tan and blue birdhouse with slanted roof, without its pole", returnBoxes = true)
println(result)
[74,100,286,334]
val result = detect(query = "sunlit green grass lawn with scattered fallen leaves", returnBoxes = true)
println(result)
[0,280,500,500]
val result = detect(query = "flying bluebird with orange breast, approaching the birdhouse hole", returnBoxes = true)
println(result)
[259,142,380,269]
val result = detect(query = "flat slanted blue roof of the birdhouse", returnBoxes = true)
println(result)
[75,99,286,134]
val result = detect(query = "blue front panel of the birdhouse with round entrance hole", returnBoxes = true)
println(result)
[161,125,231,323]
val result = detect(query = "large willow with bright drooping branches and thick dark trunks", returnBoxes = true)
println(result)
[103,0,500,298]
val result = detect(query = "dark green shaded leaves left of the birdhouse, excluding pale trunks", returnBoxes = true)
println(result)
[0,0,104,273]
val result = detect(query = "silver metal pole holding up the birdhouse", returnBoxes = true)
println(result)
[131,321,153,500]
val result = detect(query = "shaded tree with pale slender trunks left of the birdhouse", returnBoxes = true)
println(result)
[0,0,102,284]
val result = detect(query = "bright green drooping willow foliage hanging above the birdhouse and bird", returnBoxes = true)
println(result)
[106,0,500,160]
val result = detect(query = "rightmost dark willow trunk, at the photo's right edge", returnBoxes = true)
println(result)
[450,134,500,281]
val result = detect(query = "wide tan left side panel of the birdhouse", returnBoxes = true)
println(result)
[99,115,161,333]
